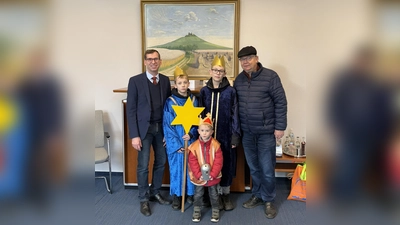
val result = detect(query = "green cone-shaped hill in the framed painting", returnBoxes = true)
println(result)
[152,33,232,52]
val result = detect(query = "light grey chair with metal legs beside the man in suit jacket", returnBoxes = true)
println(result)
[94,110,112,194]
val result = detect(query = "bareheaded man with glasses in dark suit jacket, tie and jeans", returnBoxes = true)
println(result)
[126,49,171,216]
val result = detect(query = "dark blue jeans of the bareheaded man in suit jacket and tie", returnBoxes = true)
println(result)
[136,123,167,202]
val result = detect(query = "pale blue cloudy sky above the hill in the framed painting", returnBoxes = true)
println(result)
[145,4,235,39]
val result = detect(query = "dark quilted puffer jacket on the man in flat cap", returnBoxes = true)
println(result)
[233,63,287,134]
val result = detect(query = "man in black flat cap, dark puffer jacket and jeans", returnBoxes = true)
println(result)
[233,46,287,219]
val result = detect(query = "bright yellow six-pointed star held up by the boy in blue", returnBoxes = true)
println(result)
[171,98,204,134]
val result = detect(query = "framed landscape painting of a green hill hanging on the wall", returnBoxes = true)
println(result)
[141,0,239,80]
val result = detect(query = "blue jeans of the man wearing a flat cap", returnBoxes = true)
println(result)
[242,132,276,202]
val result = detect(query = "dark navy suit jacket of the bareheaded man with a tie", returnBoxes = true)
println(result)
[126,72,171,140]
